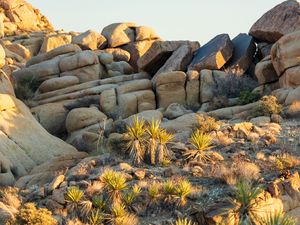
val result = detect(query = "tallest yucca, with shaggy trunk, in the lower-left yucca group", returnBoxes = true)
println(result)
[100,170,127,203]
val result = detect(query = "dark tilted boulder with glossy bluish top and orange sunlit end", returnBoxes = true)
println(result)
[189,34,233,72]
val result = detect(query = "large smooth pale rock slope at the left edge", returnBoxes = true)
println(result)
[0,94,76,185]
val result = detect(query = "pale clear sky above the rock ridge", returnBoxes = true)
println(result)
[28,0,282,44]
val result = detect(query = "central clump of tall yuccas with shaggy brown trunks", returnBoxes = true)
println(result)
[126,117,173,164]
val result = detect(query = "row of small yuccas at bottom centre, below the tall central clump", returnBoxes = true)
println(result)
[148,178,192,206]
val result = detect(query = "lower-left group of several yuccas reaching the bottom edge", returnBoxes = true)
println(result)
[65,170,141,225]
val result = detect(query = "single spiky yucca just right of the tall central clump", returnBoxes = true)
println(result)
[184,130,214,162]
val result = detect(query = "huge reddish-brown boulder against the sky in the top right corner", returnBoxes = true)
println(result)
[249,0,300,43]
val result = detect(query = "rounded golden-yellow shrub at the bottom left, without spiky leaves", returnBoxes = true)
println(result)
[17,203,58,225]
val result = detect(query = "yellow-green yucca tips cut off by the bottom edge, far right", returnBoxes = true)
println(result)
[259,212,296,225]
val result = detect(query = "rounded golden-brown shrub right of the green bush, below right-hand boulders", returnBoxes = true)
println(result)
[252,95,282,116]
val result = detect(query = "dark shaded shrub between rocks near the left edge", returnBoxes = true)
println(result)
[15,77,41,100]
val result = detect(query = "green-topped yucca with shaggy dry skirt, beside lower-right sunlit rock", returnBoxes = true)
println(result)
[231,181,262,224]
